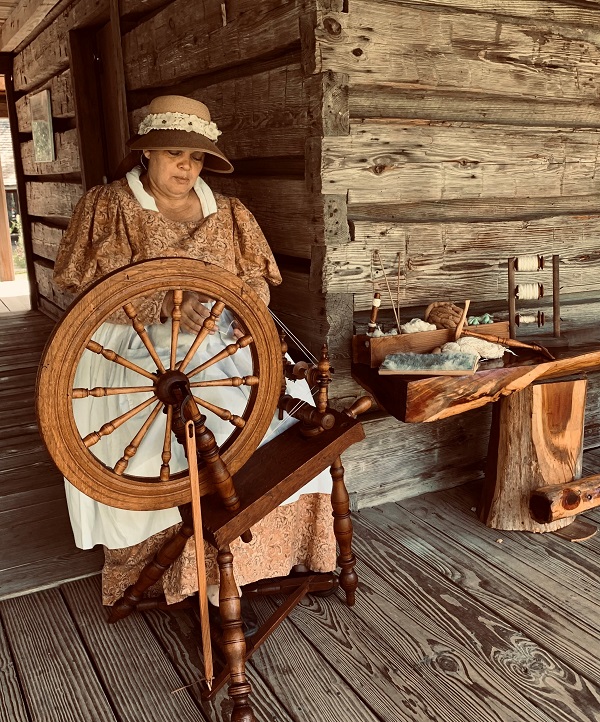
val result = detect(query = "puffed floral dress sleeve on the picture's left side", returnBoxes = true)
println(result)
[54,186,132,293]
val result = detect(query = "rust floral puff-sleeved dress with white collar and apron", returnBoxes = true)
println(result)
[54,173,335,604]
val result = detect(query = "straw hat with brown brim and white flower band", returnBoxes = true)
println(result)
[127,95,233,173]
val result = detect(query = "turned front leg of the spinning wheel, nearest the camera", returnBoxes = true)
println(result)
[217,546,256,722]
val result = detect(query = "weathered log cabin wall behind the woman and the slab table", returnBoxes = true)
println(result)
[15,0,600,507]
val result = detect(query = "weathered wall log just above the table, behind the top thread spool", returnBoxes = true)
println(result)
[322,214,600,309]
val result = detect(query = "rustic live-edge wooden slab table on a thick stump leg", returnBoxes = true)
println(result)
[352,334,600,532]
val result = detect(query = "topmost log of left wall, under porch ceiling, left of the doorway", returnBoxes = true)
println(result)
[13,0,109,92]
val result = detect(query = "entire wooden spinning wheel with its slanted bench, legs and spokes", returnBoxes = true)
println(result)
[37,258,370,722]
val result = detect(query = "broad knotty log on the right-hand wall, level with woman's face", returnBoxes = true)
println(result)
[320,121,600,203]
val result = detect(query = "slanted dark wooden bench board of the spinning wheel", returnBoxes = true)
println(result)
[201,409,365,548]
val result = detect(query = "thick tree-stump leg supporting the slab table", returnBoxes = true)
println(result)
[479,379,587,532]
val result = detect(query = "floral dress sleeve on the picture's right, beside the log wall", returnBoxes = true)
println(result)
[230,198,281,305]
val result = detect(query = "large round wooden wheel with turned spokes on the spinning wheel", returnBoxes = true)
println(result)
[37,258,282,510]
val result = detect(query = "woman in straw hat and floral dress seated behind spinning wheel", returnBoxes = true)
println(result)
[54,96,336,605]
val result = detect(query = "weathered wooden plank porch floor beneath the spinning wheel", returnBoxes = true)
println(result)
[0,314,600,722]
